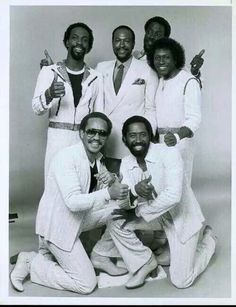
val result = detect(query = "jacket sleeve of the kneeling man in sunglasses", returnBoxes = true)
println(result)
[52,151,110,212]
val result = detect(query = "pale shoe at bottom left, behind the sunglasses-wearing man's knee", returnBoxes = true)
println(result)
[10,252,37,292]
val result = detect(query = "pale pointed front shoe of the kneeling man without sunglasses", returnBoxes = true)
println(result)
[125,254,158,289]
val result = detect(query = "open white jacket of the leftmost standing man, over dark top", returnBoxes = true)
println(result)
[32,61,103,124]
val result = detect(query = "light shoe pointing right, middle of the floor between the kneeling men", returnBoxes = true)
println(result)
[90,253,128,276]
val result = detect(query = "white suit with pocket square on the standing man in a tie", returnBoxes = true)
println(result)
[96,58,158,159]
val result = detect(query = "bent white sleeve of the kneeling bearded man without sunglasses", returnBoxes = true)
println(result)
[136,147,183,222]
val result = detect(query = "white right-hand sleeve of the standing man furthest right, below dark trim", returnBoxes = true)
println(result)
[183,78,202,133]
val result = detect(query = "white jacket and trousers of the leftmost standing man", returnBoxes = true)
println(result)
[32,61,103,181]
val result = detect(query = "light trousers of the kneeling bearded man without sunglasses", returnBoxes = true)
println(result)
[94,214,215,288]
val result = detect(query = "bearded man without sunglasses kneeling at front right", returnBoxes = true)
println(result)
[93,116,216,289]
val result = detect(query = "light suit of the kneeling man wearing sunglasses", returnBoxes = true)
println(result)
[30,142,117,293]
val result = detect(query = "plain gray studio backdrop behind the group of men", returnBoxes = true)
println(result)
[7,6,232,298]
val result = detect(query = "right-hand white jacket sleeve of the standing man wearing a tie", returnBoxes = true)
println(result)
[144,67,159,135]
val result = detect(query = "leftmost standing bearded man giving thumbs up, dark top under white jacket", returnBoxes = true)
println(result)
[32,22,102,179]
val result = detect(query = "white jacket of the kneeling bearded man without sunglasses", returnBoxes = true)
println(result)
[120,143,204,243]
